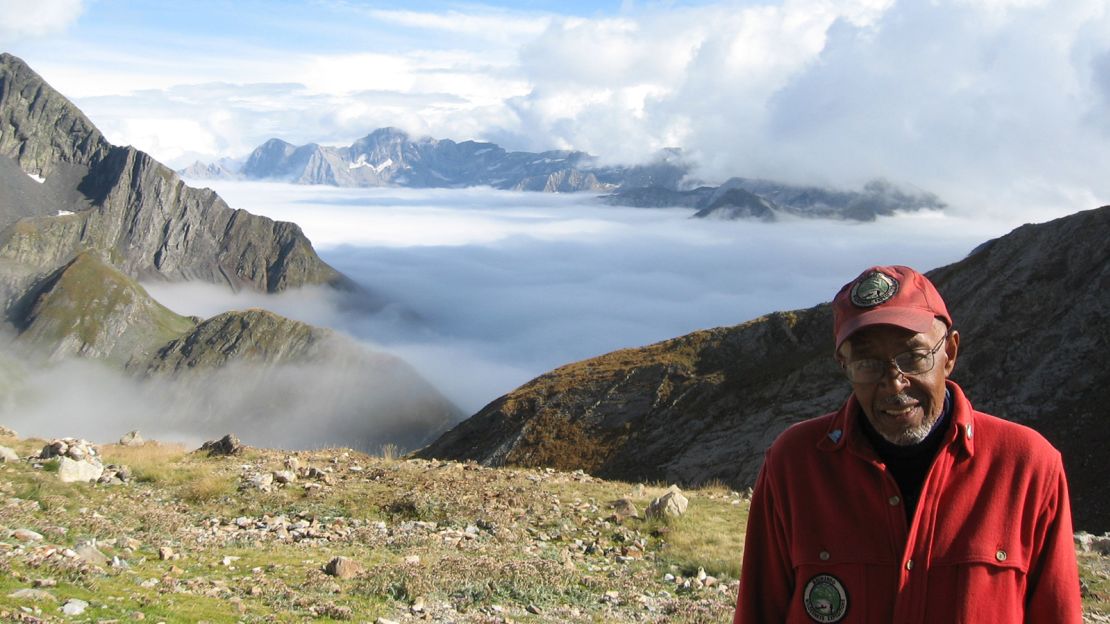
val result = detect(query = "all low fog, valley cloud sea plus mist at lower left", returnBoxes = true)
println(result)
[0,181,1070,451]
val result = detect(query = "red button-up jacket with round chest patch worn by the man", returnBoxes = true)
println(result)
[734,381,1082,624]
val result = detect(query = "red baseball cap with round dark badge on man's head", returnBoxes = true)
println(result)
[833,266,952,349]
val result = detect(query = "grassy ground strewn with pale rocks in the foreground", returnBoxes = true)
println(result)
[0,431,1110,624]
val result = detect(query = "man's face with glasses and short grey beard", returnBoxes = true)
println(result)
[837,320,960,445]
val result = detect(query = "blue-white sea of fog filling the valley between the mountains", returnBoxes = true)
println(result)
[145,181,1013,413]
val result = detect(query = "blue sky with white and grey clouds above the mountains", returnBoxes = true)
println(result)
[0,0,1110,220]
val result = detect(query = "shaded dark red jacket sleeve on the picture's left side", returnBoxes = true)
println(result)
[733,457,794,624]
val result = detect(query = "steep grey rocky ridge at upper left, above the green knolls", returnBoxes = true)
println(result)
[0,53,350,292]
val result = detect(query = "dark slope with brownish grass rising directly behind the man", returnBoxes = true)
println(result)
[418,207,1110,531]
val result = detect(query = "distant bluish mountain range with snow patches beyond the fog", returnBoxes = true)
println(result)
[179,128,945,221]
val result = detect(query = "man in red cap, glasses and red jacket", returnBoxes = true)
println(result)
[735,266,1082,624]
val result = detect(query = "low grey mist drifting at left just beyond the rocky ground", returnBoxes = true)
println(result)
[0,333,454,452]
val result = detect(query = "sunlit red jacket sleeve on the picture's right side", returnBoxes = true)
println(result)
[1026,453,1083,624]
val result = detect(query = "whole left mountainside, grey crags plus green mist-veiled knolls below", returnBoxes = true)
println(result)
[0,53,458,450]
